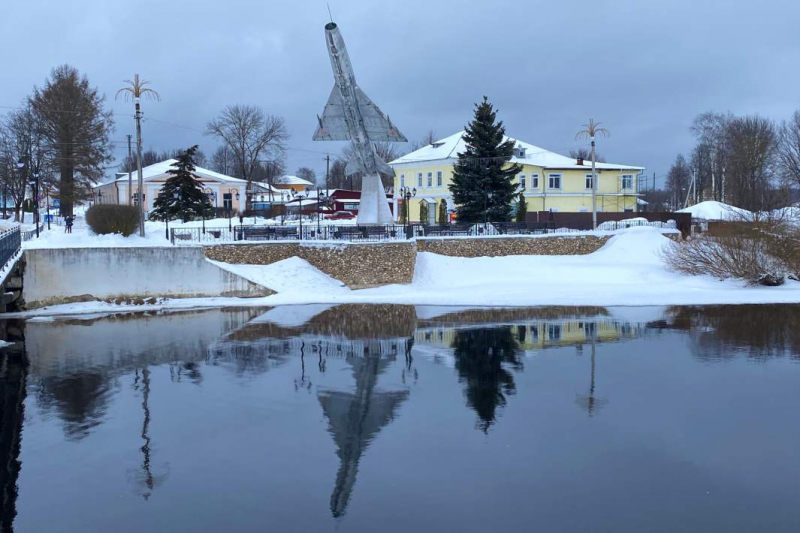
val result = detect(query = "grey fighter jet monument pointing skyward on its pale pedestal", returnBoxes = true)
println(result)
[314,22,408,224]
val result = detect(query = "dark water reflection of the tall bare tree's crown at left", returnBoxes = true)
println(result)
[36,372,112,440]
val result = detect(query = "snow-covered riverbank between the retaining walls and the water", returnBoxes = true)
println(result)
[14,227,800,316]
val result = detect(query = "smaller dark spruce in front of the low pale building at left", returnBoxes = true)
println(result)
[150,145,212,222]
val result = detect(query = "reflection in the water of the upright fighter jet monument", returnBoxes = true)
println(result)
[318,353,408,518]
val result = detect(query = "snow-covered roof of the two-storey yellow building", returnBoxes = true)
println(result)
[389,131,644,170]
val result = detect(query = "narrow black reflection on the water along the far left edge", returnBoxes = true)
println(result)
[0,354,27,531]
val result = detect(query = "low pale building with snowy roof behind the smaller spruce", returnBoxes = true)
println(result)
[92,159,247,213]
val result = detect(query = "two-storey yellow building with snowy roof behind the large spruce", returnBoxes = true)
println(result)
[389,131,644,224]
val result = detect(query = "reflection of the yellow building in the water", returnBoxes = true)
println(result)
[414,319,638,350]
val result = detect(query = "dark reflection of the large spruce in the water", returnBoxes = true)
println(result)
[452,326,522,433]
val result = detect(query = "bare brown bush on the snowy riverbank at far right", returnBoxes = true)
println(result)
[663,221,800,286]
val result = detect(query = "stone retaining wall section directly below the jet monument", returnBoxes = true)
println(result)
[206,242,417,289]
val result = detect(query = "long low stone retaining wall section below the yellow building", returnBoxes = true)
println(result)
[417,235,611,257]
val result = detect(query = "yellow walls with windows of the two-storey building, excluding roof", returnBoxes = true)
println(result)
[394,163,637,221]
